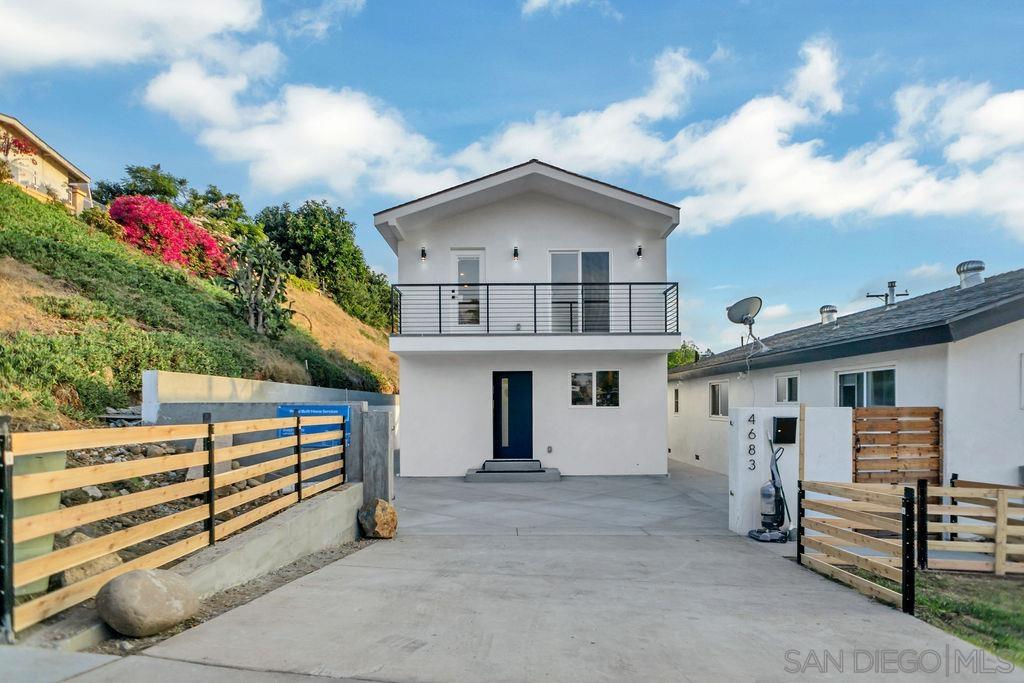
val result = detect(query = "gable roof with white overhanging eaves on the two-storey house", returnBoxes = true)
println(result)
[374,159,679,251]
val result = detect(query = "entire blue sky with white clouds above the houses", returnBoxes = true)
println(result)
[0,0,1024,350]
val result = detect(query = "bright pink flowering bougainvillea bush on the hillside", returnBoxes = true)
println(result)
[110,195,228,278]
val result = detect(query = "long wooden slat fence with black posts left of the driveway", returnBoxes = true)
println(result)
[0,415,346,641]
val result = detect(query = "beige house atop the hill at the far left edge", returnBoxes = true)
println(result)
[0,114,92,213]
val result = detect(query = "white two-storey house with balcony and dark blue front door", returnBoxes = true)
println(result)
[374,160,679,476]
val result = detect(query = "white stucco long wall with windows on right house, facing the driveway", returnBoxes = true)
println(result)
[668,344,947,474]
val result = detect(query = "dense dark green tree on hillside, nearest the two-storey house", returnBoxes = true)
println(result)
[256,200,391,327]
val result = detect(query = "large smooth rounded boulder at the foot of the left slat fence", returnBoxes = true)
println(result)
[96,569,199,638]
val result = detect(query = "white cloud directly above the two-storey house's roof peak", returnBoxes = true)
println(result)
[453,49,707,179]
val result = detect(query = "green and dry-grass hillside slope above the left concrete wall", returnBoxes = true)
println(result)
[0,183,391,422]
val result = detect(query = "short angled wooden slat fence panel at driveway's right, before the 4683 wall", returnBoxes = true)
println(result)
[797,481,915,614]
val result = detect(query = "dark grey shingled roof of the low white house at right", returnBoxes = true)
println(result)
[669,268,1024,379]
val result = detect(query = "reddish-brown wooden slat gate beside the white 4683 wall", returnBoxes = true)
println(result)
[853,407,942,485]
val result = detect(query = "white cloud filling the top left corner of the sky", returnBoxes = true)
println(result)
[0,0,260,72]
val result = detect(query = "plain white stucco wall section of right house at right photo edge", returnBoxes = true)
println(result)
[944,321,1024,484]
